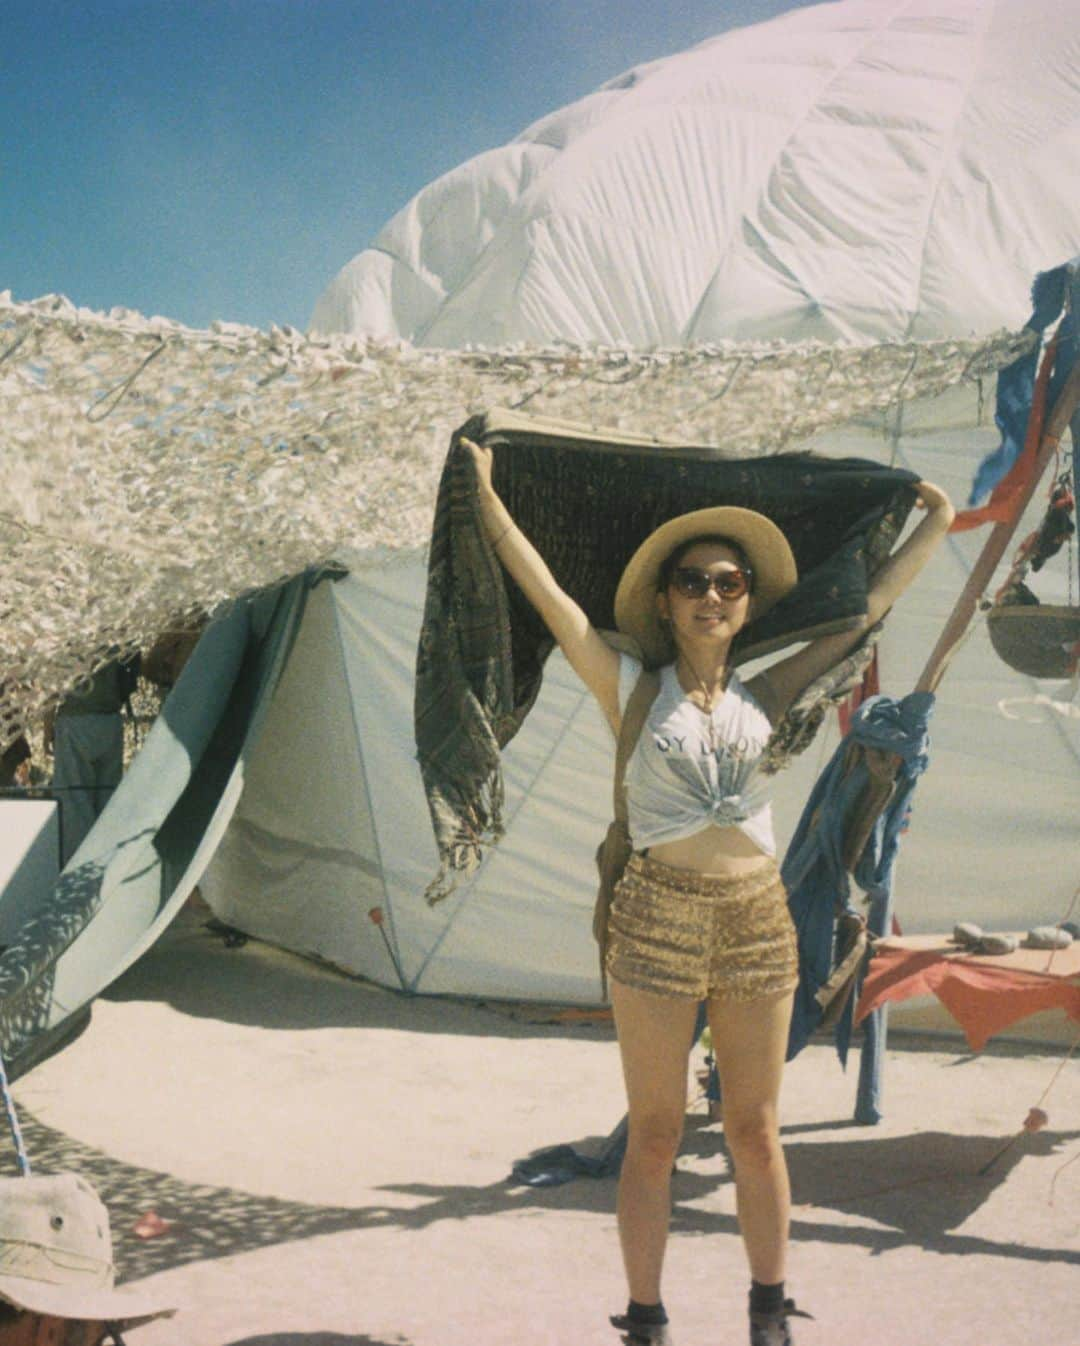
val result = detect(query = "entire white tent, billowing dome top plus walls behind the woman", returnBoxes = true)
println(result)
[206,0,1080,1000]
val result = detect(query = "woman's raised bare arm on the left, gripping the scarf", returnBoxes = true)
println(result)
[461,439,619,734]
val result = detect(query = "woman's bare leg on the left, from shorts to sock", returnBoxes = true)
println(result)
[611,981,698,1304]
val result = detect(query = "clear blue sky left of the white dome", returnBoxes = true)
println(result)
[0,0,813,327]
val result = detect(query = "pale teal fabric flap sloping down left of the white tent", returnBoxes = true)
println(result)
[0,576,314,1075]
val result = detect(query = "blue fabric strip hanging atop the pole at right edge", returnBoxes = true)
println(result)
[967,257,1080,507]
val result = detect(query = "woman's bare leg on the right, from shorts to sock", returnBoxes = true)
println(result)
[708,993,793,1285]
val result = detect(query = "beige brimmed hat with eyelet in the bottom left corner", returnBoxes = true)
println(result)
[0,1174,175,1329]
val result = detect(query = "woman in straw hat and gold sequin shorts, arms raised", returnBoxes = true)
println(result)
[462,440,953,1346]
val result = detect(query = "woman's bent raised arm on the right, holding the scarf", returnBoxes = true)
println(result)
[749,482,956,724]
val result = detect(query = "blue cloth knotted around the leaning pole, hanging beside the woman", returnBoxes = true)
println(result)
[781,692,935,1121]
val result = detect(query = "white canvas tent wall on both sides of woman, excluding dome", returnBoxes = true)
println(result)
[202,408,1080,1004]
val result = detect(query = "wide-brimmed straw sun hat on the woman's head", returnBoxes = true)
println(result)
[615,505,799,665]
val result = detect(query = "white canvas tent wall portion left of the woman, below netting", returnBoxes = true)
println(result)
[202,552,610,1003]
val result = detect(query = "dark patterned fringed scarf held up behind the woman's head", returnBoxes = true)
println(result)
[415,416,917,903]
